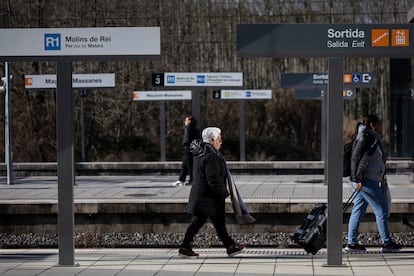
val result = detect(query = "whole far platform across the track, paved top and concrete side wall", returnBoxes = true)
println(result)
[0,174,414,233]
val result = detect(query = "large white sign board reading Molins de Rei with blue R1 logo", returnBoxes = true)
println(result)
[0,27,161,57]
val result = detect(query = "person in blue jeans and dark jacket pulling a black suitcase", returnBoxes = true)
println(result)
[344,115,402,253]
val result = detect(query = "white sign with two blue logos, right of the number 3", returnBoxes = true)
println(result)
[164,72,243,87]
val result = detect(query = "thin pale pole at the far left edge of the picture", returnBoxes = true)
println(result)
[4,62,14,185]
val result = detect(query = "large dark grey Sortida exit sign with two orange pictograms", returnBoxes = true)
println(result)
[237,24,414,58]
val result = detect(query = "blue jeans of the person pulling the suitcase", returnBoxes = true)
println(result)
[348,179,391,244]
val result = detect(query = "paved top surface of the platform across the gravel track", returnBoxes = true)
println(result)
[0,174,414,203]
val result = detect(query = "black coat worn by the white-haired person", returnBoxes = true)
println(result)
[187,140,229,216]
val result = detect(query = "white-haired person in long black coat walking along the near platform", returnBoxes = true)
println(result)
[178,127,245,258]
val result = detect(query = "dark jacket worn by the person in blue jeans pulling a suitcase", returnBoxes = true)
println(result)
[351,125,385,182]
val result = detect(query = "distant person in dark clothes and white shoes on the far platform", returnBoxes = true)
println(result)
[173,115,200,186]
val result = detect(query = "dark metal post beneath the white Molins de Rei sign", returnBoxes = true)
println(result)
[56,61,75,266]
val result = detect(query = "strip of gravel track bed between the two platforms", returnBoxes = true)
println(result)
[0,232,414,248]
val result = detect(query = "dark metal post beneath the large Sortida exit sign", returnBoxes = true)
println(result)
[325,58,344,266]
